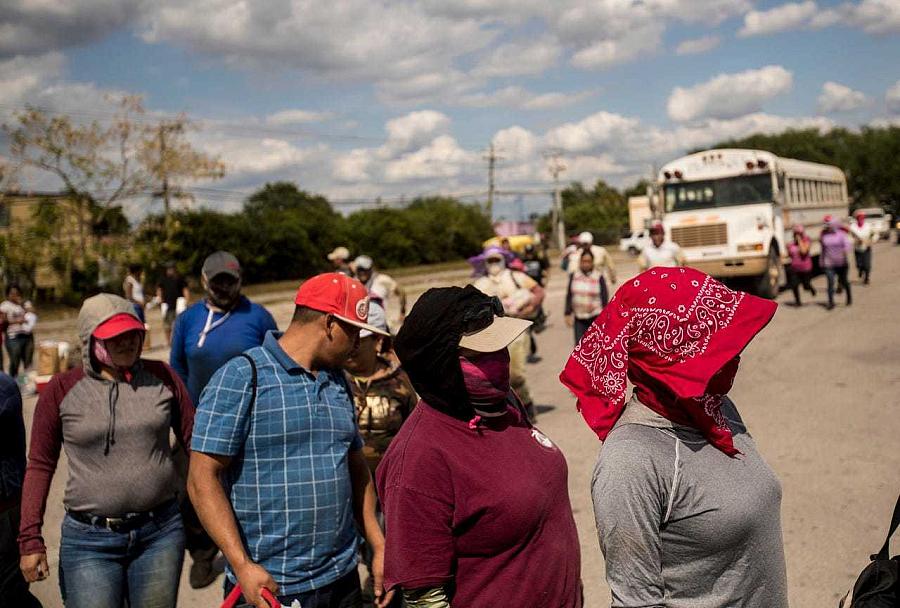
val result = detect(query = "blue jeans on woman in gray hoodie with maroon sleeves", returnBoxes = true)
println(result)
[59,502,184,608]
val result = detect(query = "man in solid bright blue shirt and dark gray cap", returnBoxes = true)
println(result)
[169,251,278,589]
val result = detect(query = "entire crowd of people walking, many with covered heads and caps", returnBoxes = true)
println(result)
[0,218,877,608]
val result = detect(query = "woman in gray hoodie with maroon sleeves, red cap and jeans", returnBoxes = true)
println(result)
[19,294,194,608]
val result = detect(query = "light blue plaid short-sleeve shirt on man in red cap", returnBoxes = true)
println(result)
[191,332,363,595]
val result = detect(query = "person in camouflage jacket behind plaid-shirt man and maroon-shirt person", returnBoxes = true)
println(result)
[344,300,418,607]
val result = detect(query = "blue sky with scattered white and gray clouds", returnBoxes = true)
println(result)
[0,0,900,218]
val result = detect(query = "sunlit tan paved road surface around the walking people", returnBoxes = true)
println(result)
[19,243,900,608]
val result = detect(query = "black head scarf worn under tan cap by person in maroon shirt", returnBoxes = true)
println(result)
[394,285,503,420]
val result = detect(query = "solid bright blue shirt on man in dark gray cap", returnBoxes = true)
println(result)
[169,296,278,403]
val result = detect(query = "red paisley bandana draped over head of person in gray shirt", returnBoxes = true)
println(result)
[559,268,777,456]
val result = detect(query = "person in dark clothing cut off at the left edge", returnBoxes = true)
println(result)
[0,371,41,608]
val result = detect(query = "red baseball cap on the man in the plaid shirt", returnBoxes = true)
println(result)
[294,272,390,336]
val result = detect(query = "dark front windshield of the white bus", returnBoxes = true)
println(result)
[664,173,773,212]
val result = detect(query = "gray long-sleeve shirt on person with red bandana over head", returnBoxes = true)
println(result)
[592,397,788,608]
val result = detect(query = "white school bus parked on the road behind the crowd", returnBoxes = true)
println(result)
[658,149,848,298]
